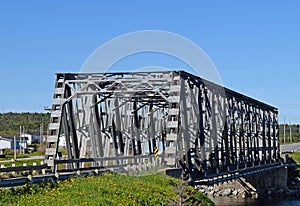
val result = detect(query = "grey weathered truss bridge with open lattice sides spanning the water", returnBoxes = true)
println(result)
[45,71,280,181]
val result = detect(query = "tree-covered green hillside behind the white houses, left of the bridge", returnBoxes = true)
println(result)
[0,112,50,136]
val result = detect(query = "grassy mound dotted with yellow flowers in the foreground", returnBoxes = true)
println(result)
[0,173,214,206]
